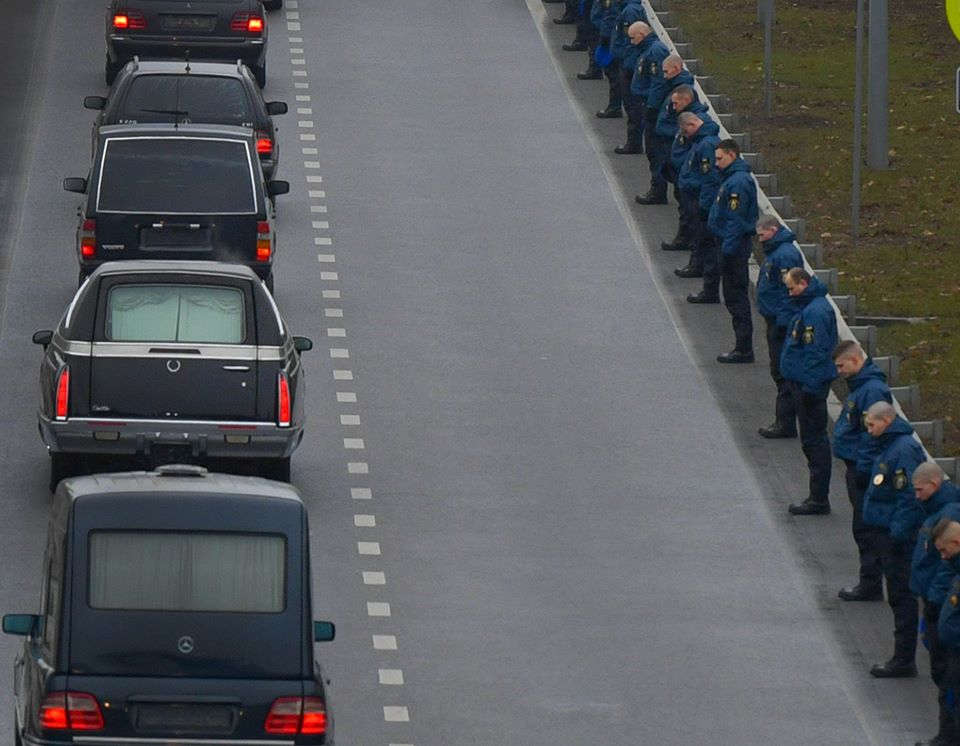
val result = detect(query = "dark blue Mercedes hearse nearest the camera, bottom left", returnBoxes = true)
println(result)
[3,465,334,746]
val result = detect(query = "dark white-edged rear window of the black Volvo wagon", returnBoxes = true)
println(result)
[97,137,259,215]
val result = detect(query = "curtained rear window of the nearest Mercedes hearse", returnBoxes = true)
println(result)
[87,531,286,613]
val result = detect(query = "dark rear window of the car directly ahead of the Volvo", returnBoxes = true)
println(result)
[117,75,253,127]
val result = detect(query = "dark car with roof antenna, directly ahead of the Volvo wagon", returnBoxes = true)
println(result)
[83,60,287,179]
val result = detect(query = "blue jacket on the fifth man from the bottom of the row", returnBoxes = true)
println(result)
[784,276,837,395]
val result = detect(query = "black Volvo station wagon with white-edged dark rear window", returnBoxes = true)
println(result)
[63,124,290,288]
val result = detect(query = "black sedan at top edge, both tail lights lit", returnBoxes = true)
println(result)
[105,0,267,88]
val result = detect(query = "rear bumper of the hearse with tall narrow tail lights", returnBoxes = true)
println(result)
[39,414,303,459]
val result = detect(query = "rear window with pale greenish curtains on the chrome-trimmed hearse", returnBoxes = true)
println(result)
[104,285,246,344]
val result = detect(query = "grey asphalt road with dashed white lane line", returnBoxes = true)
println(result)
[0,0,933,746]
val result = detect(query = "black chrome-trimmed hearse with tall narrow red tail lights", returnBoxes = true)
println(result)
[33,261,313,489]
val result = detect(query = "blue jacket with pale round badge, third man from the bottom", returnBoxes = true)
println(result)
[863,417,927,532]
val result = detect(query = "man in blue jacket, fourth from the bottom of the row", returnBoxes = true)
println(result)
[833,340,893,601]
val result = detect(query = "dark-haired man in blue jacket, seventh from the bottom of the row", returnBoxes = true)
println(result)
[687,140,758,363]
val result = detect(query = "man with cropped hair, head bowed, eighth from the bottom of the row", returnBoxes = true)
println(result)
[676,107,720,276]
